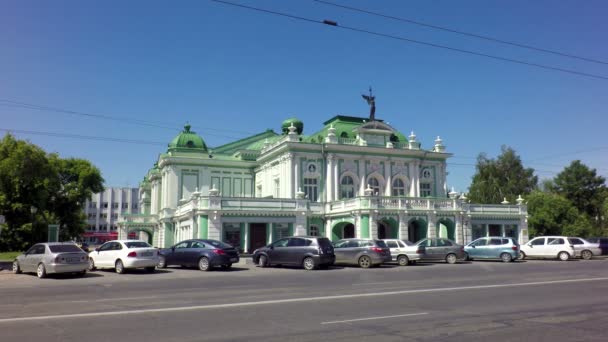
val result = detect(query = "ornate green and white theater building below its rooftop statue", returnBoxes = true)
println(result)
[119,115,528,252]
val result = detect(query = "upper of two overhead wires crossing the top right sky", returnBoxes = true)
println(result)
[313,0,608,64]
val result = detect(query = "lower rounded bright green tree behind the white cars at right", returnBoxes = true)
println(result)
[526,191,591,237]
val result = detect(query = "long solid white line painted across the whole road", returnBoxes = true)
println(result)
[0,277,608,324]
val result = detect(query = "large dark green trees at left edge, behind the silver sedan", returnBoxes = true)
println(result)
[0,134,103,251]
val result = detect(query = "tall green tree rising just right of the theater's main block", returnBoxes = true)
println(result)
[469,146,538,204]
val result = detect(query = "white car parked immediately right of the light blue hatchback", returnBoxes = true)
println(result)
[520,236,575,261]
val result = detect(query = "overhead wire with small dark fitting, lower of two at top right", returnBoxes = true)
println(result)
[210,0,608,80]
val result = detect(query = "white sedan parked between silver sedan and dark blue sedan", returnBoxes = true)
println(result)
[89,240,159,274]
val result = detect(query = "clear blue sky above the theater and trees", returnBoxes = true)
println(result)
[0,0,608,191]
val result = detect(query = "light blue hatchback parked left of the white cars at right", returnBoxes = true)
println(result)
[464,236,519,262]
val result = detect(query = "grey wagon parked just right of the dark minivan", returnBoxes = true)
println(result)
[334,239,391,268]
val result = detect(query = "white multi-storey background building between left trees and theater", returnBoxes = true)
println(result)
[82,187,139,243]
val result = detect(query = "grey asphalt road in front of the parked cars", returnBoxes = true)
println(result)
[0,259,608,342]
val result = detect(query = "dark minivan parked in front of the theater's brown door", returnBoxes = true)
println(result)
[253,236,336,270]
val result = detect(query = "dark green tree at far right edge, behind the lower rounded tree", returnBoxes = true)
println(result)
[552,160,606,226]
